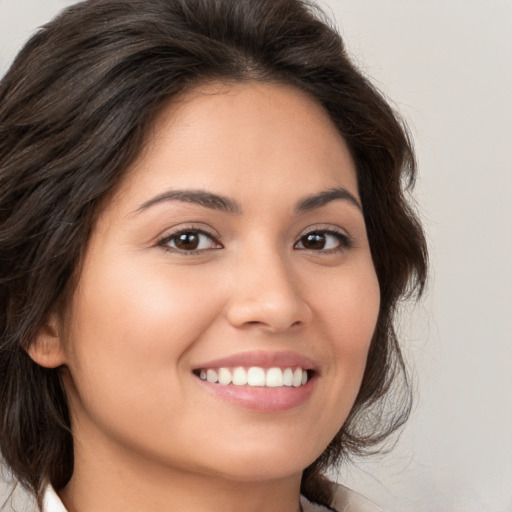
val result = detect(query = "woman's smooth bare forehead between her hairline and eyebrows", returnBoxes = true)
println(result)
[112,82,357,212]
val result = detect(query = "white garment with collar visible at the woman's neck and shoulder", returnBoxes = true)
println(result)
[43,485,384,512]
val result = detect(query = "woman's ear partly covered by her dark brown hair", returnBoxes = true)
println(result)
[27,313,66,368]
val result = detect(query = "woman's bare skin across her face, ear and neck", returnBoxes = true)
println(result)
[30,83,379,512]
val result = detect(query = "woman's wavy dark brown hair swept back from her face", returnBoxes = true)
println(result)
[0,0,426,505]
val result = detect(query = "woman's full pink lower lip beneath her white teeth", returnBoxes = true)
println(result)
[197,377,316,412]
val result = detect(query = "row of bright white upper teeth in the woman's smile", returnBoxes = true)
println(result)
[199,366,308,388]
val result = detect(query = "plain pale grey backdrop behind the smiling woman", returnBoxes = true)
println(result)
[0,0,512,512]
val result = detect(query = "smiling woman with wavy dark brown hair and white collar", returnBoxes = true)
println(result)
[0,0,426,512]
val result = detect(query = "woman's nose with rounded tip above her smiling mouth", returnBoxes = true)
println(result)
[227,252,312,333]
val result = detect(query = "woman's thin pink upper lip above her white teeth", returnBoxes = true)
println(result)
[195,350,317,370]
